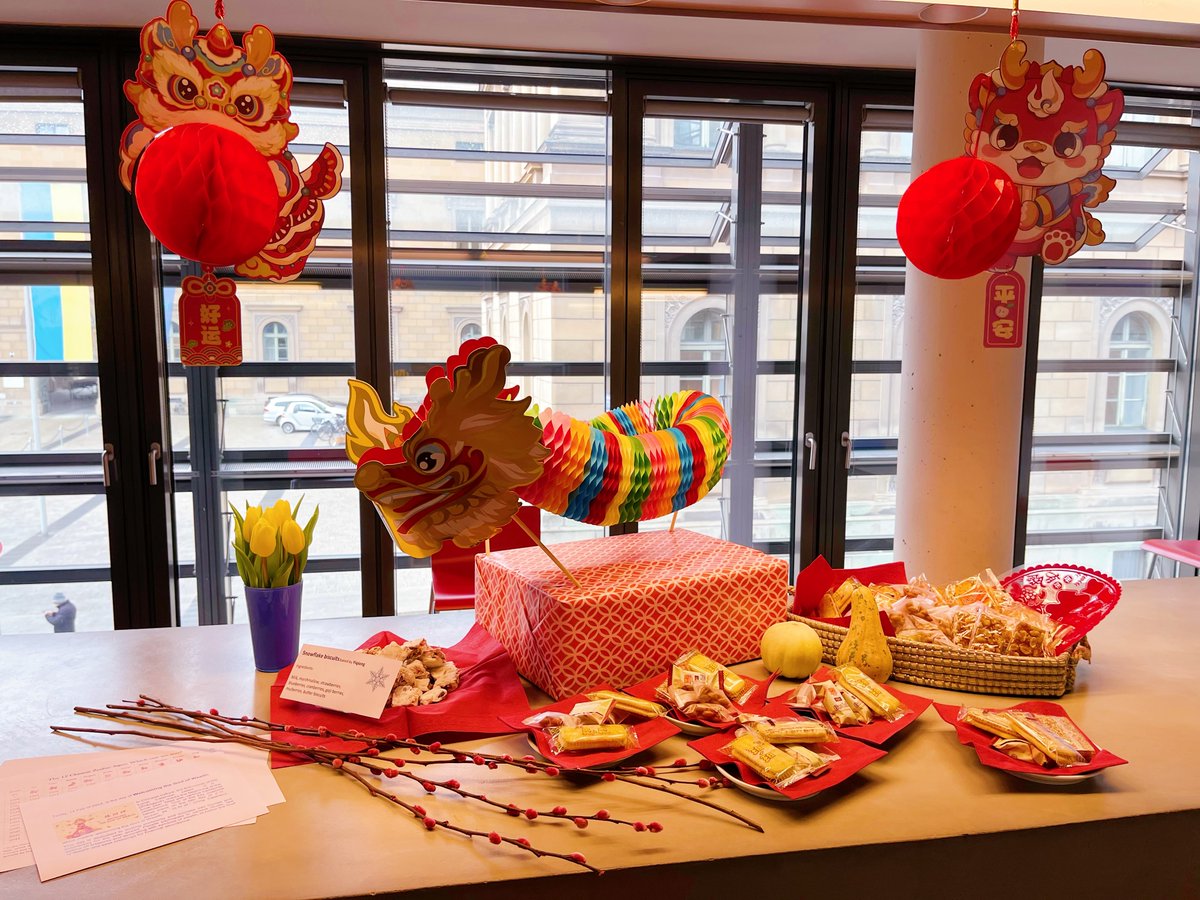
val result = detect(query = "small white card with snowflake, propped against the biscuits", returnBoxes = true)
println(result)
[280,643,401,719]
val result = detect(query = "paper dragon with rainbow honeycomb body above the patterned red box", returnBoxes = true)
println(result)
[346,337,730,557]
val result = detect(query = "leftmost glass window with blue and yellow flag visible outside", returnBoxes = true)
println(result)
[0,70,113,634]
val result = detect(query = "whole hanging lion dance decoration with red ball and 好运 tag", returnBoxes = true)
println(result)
[120,0,342,365]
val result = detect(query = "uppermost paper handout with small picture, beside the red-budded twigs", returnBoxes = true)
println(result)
[20,760,265,881]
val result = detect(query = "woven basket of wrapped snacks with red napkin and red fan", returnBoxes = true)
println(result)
[788,559,1121,697]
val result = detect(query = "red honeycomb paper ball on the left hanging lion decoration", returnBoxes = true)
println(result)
[133,122,280,266]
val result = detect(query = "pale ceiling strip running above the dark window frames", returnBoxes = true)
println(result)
[0,0,1200,79]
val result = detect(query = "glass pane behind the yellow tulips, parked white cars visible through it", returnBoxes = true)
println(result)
[163,84,362,623]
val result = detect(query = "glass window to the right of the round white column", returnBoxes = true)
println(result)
[1025,98,1200,577]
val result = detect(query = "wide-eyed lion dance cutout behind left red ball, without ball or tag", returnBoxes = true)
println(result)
[120,0,342,282]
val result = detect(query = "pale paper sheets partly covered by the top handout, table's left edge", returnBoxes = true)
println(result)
[0,744,283,872]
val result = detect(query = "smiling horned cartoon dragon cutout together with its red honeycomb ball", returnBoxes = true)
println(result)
[896,40,1124,278]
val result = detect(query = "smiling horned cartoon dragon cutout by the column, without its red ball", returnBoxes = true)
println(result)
[965,41,1124,271]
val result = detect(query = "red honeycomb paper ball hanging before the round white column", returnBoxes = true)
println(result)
[896,156,1021,278]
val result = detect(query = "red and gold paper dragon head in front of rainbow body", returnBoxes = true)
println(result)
[346,337,550,558]
